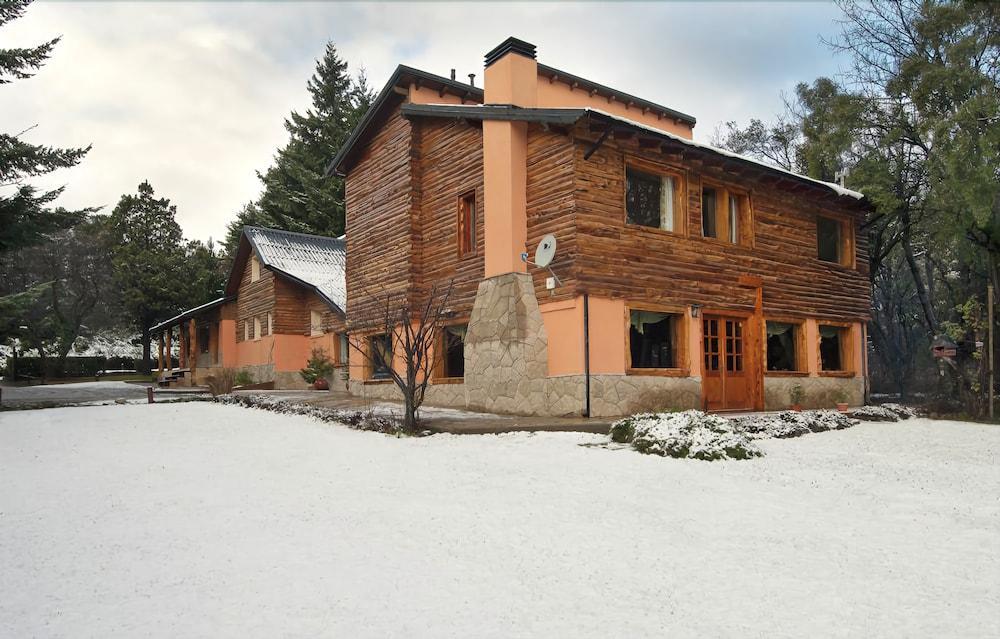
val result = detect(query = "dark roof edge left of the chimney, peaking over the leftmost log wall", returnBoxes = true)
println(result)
[326,64,483,177]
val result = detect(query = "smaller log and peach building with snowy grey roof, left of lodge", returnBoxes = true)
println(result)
[152,227,348,389]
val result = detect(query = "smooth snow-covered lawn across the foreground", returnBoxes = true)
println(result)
[0,403,1000,638]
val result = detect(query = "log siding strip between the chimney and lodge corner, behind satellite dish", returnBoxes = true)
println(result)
[525,125,578,301]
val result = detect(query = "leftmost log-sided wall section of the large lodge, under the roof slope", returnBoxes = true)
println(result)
[345,107,419,322]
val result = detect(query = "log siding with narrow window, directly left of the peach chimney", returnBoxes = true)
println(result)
[414,118,485,315]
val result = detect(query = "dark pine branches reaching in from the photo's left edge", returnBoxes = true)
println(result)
[0,0,93,251]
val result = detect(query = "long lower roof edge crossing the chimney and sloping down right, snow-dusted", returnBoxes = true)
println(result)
[402,104,865,200]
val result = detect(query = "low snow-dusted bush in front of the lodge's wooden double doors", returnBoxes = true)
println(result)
[611,410,764,461]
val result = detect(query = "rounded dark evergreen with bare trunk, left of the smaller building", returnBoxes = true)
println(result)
[109,182,188,373]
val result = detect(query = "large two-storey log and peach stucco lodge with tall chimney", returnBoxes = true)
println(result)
[326,38,870,416]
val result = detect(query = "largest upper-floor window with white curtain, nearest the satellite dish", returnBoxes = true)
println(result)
[625,167,684,233]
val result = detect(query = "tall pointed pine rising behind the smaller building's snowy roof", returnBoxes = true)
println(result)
[254,43,374,236]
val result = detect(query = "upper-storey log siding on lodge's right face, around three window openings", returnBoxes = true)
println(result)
[572,129,870,320]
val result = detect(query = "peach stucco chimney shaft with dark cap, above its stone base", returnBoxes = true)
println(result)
[483,38,538,277]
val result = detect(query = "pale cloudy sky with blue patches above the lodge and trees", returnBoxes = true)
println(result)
[0,2,840,245]
